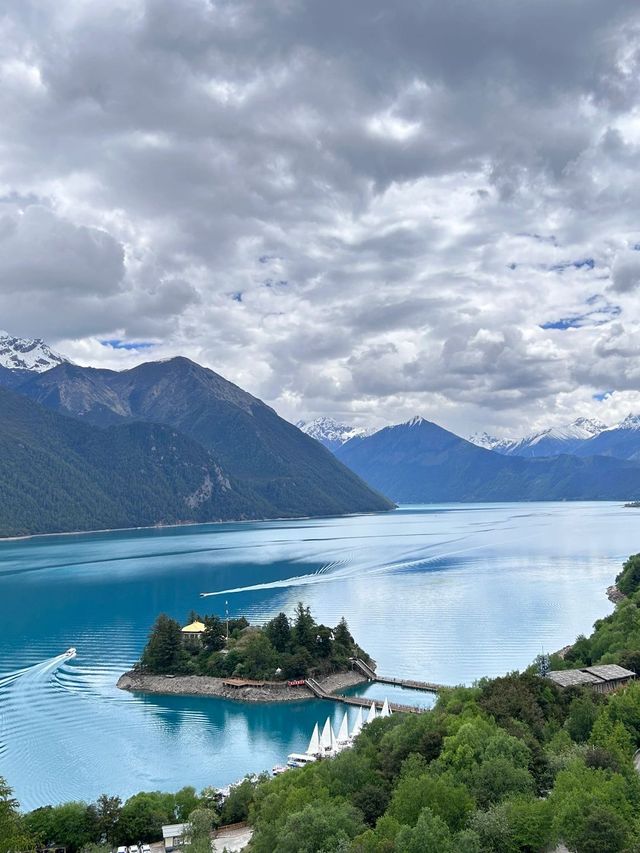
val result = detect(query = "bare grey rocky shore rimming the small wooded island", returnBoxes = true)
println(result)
[116,669,367,702]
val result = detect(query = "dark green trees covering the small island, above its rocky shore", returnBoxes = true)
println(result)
[138,602,370,681]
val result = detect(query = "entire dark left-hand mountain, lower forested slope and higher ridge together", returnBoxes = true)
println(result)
[0,332,393,535]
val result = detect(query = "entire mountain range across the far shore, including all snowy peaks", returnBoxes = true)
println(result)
[0,326,640,536]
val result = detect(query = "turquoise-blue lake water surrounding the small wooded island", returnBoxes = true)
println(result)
[0,503,640,808]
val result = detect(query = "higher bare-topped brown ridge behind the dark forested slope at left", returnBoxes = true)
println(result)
[13,358,393,518]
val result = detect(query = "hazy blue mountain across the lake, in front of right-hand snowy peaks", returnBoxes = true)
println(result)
[336,417,640,503]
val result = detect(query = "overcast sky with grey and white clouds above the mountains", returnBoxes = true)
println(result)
[0,0,640,436]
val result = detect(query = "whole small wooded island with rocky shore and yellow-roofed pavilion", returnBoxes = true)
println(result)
[118,602,373,702]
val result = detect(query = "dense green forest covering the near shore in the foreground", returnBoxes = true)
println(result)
[0,554,640,853]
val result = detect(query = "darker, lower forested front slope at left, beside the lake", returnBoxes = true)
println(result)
[0,388,266,536]
